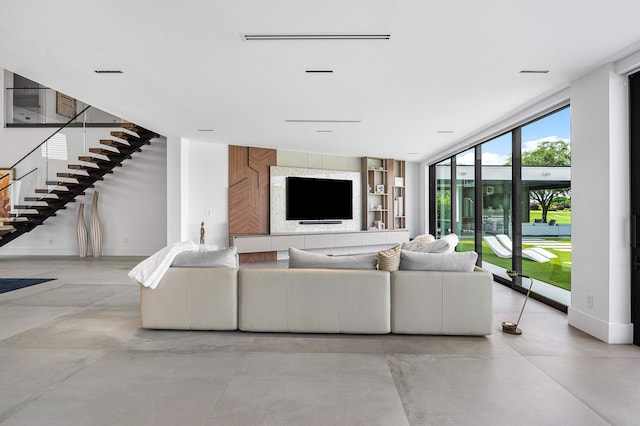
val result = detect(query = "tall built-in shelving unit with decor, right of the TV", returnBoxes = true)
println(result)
[362,157,406,231]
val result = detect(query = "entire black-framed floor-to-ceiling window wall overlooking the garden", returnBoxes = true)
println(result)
[430,107,571,306]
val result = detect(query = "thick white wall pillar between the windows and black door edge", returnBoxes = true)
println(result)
[568,65,633,343]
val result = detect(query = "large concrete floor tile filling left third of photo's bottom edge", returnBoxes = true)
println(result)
[6,352,244,426]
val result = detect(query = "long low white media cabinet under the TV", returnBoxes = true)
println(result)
[229,229,409,253]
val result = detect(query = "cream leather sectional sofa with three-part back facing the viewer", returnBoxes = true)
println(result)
[140,267,493,335]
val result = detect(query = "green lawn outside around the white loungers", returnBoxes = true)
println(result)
[457,235,571,291]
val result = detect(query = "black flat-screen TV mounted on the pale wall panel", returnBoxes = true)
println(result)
[286,176,353,220]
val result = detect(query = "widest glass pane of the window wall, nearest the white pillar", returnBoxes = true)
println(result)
[521,108,571,304]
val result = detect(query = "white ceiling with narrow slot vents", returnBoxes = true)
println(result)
[0,0,640,161]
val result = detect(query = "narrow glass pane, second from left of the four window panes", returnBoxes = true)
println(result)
[455,148,476,251]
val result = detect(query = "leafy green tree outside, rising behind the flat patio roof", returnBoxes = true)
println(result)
[522,141,571,223]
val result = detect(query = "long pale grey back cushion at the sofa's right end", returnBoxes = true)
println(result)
[400,250,478,272]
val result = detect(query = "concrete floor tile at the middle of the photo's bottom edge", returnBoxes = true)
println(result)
[207,353,408,425]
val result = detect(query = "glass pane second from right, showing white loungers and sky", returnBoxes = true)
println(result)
[481,133,512,278]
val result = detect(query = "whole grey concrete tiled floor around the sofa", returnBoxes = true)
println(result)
[0,256,640,425]
